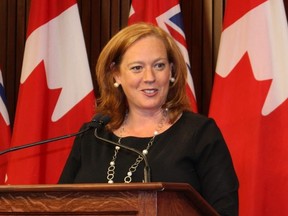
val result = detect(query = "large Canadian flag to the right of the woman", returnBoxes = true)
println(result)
[209,0,288,216]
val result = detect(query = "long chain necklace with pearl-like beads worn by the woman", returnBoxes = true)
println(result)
[107,110,167,184]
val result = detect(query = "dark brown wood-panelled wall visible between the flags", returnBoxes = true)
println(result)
[0,0,288,125]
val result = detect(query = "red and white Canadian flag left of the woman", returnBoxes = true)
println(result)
[6,0,95,184]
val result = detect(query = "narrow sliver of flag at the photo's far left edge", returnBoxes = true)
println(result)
[0,69,11,184]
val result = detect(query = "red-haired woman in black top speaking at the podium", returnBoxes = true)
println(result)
[59,23,238,215]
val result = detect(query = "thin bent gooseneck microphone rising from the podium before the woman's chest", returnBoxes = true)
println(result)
[94,116,151,183]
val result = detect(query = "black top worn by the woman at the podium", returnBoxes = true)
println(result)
[59,112,238,215]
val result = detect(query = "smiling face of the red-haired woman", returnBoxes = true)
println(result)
[115,36,172,111]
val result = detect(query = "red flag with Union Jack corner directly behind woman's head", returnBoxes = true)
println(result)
[128,0,198,112]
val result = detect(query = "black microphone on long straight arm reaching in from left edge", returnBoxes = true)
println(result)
[0,114,107,155]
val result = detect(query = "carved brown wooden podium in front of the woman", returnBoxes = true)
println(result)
[0,182,218,216]
